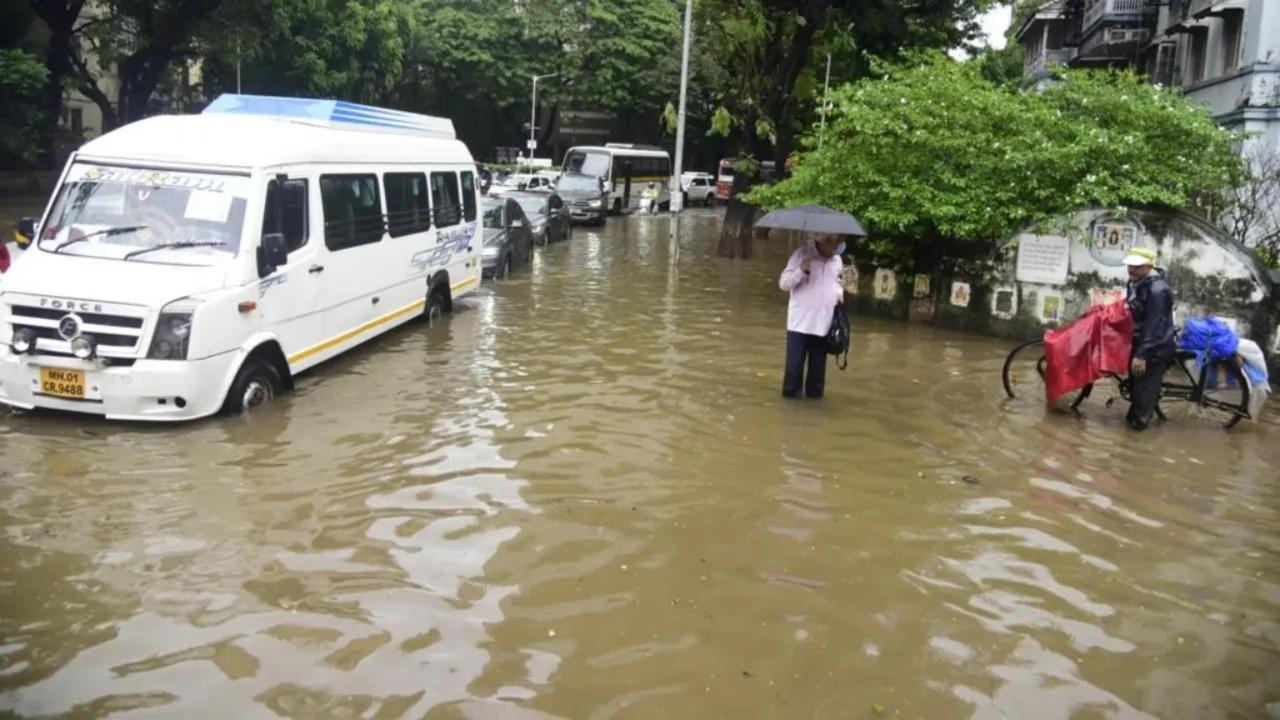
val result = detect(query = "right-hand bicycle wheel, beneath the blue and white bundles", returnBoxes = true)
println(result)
[1157,354,1249,428]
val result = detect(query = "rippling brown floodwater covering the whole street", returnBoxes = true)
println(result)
[0,210,1280,719]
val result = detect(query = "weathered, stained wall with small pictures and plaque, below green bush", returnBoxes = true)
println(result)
[849,210,1280,378]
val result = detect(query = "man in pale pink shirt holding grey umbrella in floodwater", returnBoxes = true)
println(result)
[756,205,867,398]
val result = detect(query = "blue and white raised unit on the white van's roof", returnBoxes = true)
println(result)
[202,94,457,140]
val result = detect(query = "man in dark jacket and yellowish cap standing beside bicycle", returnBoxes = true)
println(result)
[1124,247,1174,430]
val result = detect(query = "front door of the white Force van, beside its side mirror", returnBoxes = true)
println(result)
[259,178,324,372]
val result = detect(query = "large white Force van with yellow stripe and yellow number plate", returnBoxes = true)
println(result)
[0,95,481,420]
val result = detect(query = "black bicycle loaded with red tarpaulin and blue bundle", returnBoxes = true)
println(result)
[1001,340,1249,428]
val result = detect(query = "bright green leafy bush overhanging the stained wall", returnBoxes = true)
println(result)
[750,54,1243,266]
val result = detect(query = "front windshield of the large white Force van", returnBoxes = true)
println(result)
[40,163,250,265]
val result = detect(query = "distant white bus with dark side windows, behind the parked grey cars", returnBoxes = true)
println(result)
[563,142,671,214]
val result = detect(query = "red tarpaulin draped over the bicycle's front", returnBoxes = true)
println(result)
[1044,302,1133,404]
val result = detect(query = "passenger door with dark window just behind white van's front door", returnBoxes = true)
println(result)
[319,173,396,359]
